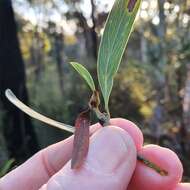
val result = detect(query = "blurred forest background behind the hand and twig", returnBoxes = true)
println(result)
[0,0,190,181]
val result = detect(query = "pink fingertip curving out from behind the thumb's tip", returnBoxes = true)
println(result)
[111,118,144,150]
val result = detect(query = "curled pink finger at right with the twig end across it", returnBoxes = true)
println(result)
[129,145,183,190]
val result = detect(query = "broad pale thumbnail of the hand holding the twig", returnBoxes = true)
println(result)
[86,127,134,174]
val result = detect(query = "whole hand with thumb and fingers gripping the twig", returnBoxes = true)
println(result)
[0,119,190,190]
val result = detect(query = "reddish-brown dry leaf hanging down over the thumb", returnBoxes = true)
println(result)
[71,110,90,169]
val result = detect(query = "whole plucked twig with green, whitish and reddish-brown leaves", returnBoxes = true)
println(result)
[6,0,168,176]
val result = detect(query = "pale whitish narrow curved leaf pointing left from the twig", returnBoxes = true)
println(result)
[5,89,74,133]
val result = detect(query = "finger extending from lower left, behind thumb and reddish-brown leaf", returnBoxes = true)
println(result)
[0,124,100,190]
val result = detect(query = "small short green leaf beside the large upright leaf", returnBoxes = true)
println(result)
[70,62,96,92]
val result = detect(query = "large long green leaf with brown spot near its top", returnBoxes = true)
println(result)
[97,0,141,113]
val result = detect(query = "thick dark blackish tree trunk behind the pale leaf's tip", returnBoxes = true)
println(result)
[0,0,38,161]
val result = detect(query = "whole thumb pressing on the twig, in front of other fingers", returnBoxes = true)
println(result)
[41,127,136,190]
